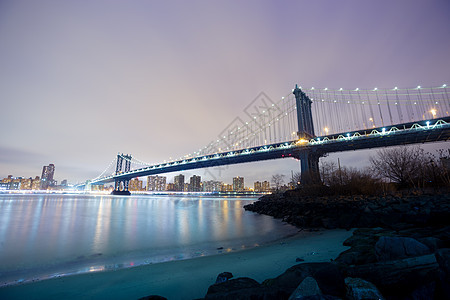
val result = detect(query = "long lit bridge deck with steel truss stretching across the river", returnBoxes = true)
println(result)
[90,117,450,184]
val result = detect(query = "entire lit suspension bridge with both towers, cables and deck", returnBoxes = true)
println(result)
[79,84,450,195]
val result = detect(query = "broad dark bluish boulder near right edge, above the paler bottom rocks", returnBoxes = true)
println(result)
[375,236,431,261]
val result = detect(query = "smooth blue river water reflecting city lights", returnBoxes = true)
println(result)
[0,194,297,286]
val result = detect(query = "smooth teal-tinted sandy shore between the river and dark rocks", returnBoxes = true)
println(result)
[0,229,352,300]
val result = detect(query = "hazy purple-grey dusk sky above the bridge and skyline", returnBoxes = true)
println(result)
[0,0,450,186]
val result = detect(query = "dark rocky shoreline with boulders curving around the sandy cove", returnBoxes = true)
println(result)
[201,191,450,299]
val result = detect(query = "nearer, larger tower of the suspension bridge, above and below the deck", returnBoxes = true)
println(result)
[293,84,321,185]
